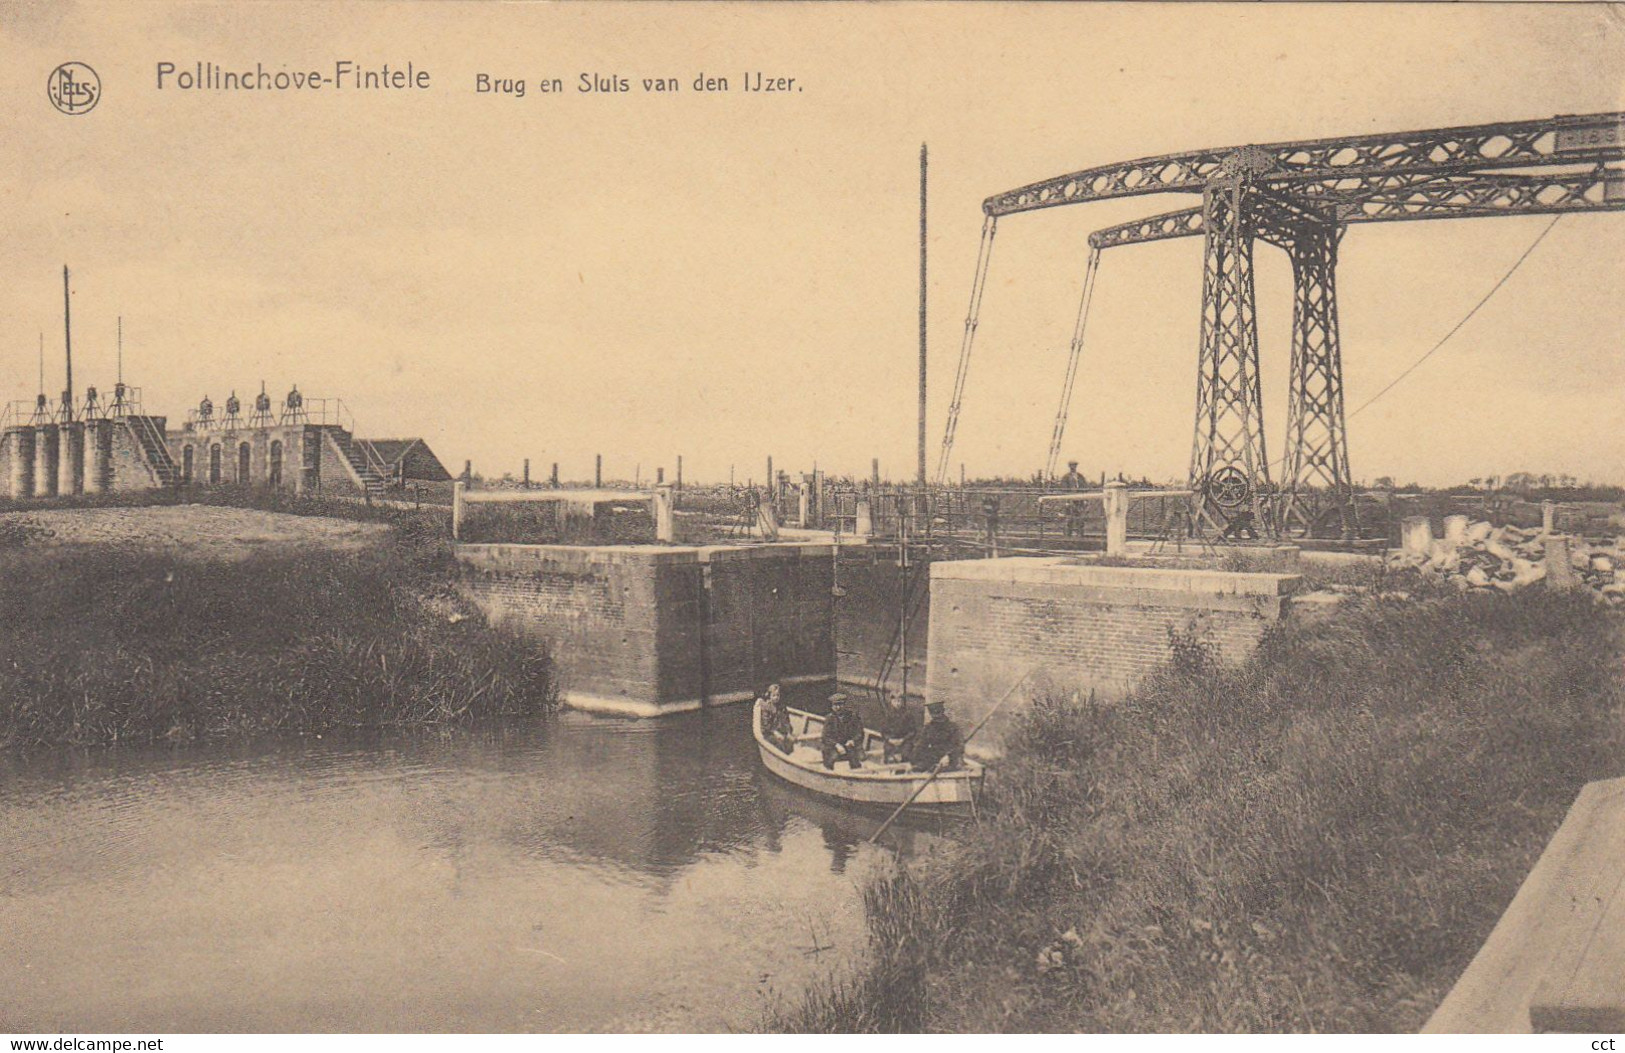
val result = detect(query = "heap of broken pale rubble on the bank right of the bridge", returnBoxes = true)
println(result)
[1388,522,1625,606]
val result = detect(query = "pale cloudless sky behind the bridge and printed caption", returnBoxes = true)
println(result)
[0,3,1625,483]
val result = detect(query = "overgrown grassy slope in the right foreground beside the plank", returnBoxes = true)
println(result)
[774,590,1625,1032]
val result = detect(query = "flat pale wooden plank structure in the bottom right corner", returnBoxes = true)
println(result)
[1422,778,1625,1034]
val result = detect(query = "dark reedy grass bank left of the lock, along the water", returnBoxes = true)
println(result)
[0,520,554,748]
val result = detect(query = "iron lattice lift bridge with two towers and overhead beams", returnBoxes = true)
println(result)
[936,112,1625,538]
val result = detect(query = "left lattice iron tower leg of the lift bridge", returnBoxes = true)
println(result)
[1190,177,1271,536]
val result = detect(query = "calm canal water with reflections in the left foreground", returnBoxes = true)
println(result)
[0,705,934,1032]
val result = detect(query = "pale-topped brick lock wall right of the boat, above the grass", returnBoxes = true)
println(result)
[926,557,1297,748]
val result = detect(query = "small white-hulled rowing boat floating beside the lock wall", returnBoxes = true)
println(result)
[751,700,982,808]
